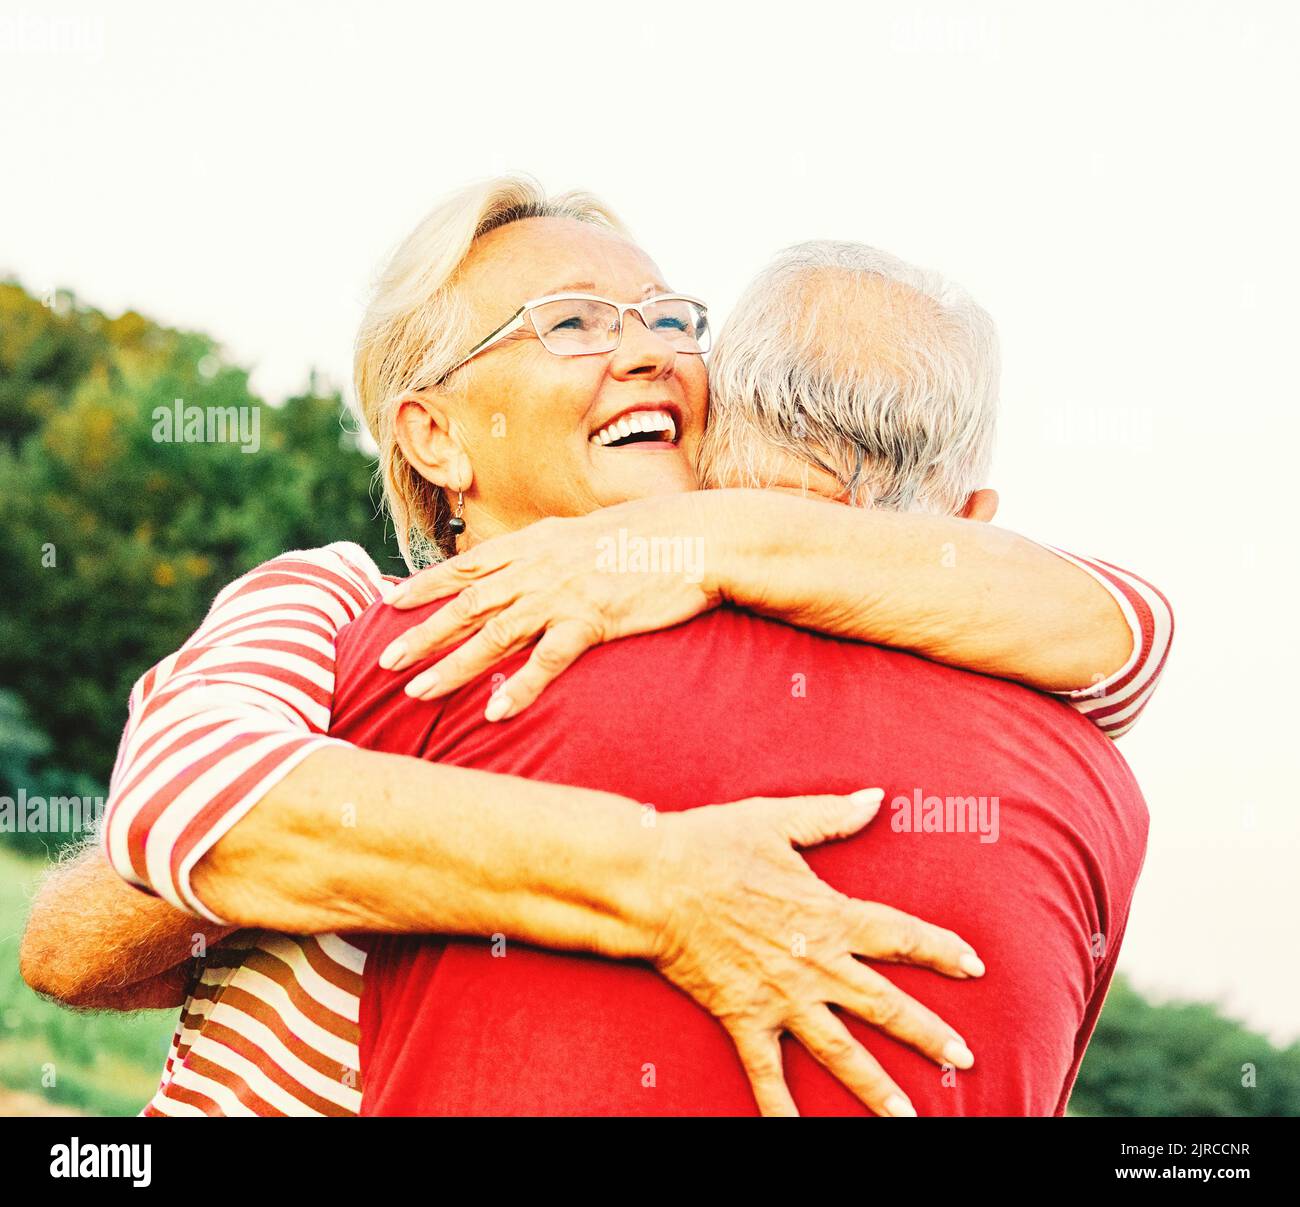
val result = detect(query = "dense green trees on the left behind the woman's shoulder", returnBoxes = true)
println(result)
[0,282,398,793]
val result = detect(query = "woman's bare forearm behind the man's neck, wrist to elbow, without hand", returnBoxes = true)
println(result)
[706,490,1132,691]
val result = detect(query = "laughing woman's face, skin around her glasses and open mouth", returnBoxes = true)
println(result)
[431,219,709,540]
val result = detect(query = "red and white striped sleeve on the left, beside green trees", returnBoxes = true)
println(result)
[103,541,397,922]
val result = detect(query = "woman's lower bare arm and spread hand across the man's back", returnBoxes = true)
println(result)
[192,748,983,1115]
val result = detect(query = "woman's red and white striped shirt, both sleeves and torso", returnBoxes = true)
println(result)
[104,542,1173,1116]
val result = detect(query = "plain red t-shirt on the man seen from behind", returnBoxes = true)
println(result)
[330,605,1148,1115]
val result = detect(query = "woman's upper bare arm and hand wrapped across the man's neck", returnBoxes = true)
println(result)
[381,490,1171,723]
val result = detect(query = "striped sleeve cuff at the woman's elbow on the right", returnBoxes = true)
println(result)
[1047,545,1174,737]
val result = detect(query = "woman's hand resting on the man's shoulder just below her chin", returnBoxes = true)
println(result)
[380,492,720,721]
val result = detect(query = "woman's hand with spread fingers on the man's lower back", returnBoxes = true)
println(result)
[655,789,984,1116]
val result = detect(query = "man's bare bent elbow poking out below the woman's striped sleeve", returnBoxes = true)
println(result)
[18,844,233,1011]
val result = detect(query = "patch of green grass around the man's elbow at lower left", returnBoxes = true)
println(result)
[0,847,177,1115]
